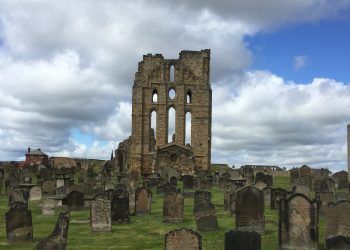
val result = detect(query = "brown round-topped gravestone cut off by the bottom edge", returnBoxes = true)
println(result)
[164,228,202,250]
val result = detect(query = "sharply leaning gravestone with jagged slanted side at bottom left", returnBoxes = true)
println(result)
[35,212,70,250]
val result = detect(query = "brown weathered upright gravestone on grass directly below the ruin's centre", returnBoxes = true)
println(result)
[163,190,184,223]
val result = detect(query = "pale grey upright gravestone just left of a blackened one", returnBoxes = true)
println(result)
[90,196,112,232]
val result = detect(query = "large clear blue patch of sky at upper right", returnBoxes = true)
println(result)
[246,18,350,83]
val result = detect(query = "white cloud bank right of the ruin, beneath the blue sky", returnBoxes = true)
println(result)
[212,71,350,169]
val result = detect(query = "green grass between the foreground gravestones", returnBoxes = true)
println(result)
[0,177,325,250]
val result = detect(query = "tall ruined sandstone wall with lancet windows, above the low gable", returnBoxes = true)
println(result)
[128,49,212,175]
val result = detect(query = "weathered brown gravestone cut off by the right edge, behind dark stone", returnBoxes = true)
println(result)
[326,200,350,238]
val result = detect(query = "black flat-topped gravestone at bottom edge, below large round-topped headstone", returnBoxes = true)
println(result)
[225,230,261,250]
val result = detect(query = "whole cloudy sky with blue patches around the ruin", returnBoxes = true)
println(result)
[0,0,350,171]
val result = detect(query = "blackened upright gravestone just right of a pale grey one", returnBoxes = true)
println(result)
[111,191,130,224]
